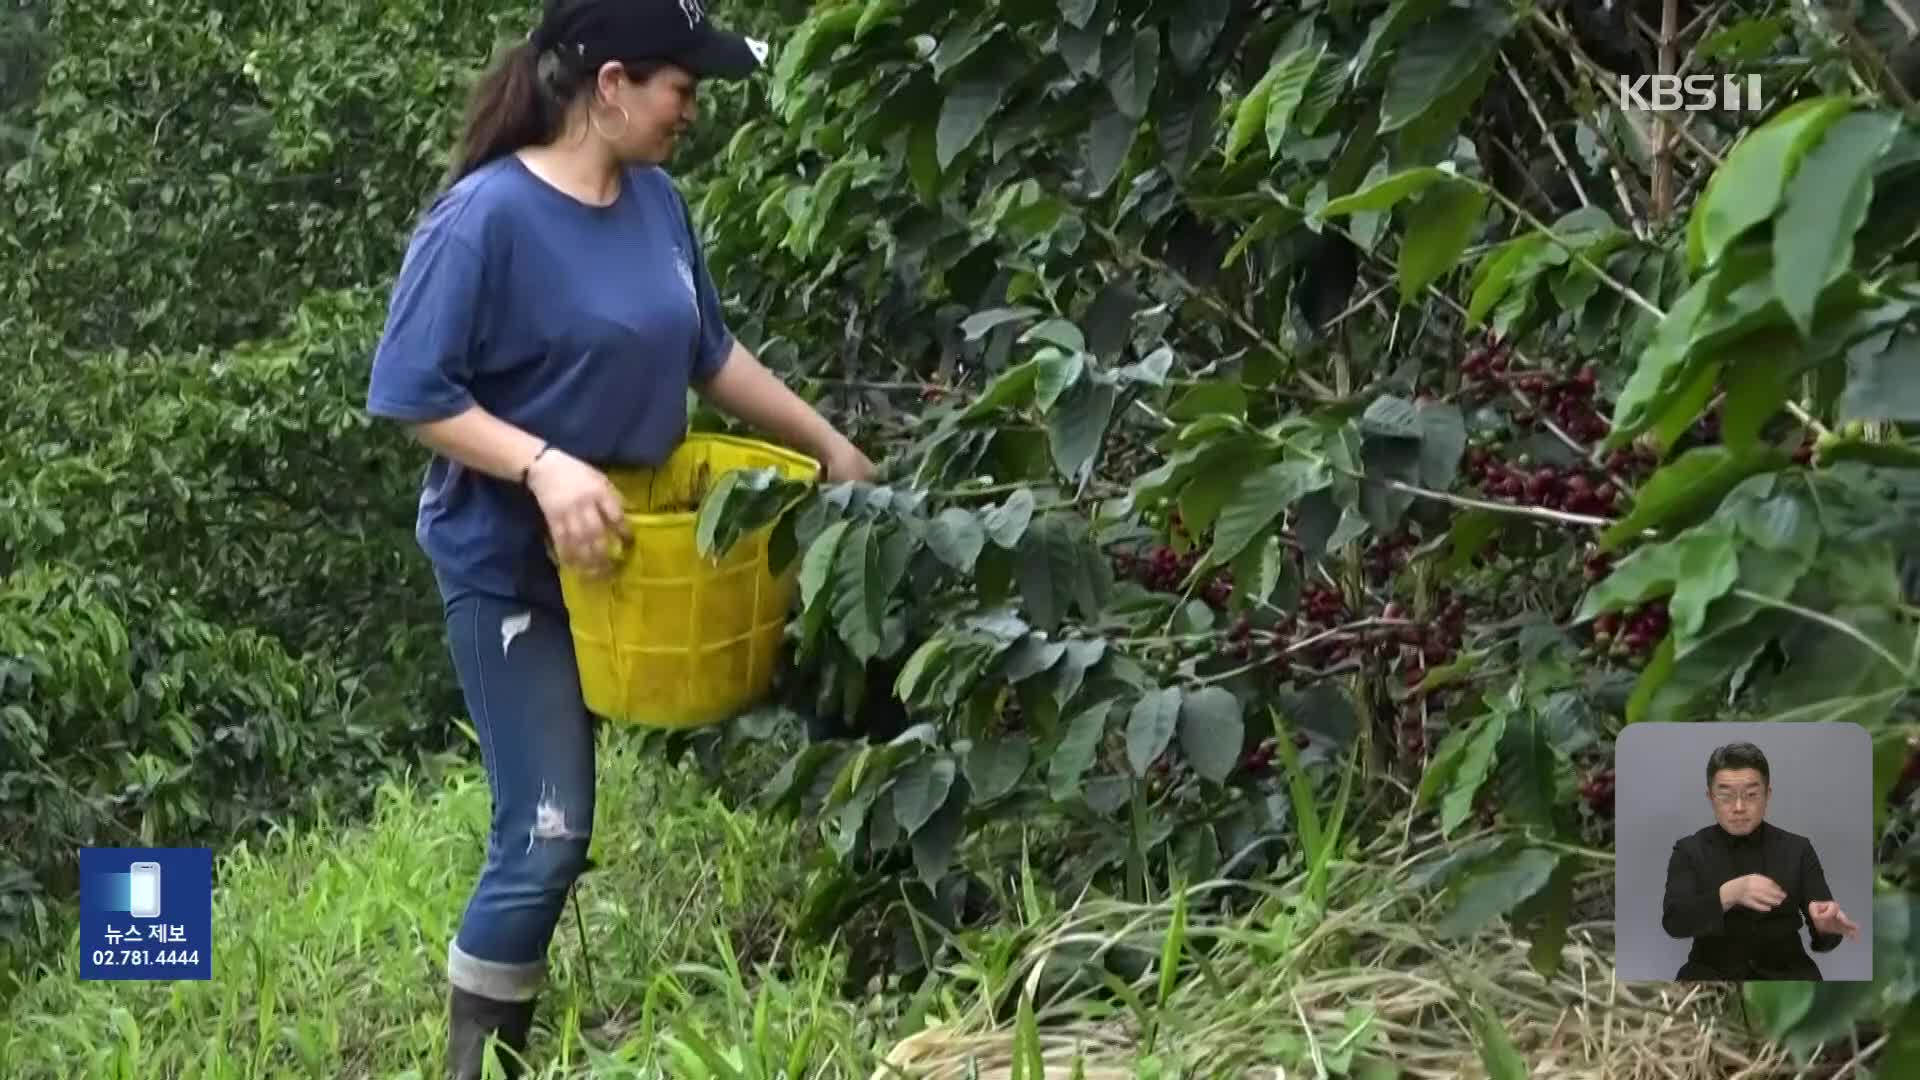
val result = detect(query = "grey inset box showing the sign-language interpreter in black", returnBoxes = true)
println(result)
[1613,723,1874,982]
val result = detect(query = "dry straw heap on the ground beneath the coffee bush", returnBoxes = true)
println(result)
[874,814,1797,1080]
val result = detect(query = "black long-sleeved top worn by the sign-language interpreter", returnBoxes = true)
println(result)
[1661,821,1841,980]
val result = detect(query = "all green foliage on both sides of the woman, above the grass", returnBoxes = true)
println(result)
[0,0,1920,1053]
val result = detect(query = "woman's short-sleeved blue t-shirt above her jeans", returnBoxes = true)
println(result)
[367,154,733,607]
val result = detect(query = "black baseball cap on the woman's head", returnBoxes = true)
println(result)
[526,0,766,79]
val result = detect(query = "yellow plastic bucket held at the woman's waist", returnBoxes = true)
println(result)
[561,432,820,728]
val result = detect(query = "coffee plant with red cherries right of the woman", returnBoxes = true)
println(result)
[664,0,1920,1040]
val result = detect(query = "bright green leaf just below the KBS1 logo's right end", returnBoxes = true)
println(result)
[1688,98,1847,269]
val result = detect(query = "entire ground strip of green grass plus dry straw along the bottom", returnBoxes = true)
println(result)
[0,726,1827,1080]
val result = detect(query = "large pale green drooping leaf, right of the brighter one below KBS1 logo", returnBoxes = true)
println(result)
[1774,113,1899,336]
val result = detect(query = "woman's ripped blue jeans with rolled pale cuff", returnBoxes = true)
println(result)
[445,592,595,1001]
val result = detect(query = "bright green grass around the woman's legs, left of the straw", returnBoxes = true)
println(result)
[0,738,879,1080]
